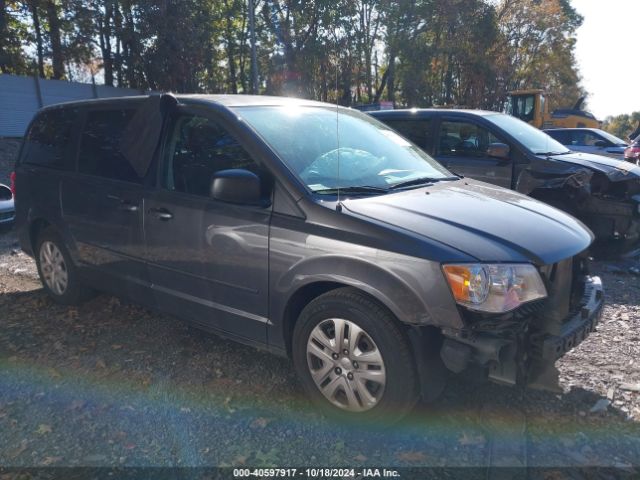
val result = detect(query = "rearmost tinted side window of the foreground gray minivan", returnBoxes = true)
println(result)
[22,109,77,168]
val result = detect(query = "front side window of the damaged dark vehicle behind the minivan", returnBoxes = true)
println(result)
[438,121,504,157]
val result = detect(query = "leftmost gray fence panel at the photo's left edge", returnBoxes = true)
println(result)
[0,75,39,137]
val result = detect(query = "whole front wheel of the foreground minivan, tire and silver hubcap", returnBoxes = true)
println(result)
[292,288,418,422]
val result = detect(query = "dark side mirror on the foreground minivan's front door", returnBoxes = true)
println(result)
[210,169,262,205]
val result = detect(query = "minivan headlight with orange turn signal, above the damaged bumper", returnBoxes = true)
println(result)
[442,263,547,313]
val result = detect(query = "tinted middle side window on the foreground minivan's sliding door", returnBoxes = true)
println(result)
[78,109,142,183]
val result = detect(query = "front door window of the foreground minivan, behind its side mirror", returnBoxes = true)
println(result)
[165,116,260,197]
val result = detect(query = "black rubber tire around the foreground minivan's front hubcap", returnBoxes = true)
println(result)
[292,288,419,423]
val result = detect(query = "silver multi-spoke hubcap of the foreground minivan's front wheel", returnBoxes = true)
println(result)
[307,318,386,412]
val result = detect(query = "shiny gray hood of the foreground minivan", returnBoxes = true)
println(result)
[342,179,593,265]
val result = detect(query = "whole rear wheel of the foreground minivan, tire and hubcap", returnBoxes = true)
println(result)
[35,227,93,305]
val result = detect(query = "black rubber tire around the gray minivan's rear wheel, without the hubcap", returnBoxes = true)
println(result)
[34,227,94,305]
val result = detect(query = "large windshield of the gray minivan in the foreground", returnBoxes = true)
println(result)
[236,106,455,194]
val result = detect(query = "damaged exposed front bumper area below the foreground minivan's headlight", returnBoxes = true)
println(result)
[440,276,604,390]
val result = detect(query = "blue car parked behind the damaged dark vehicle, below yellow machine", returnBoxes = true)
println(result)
[544,128,629,160]
